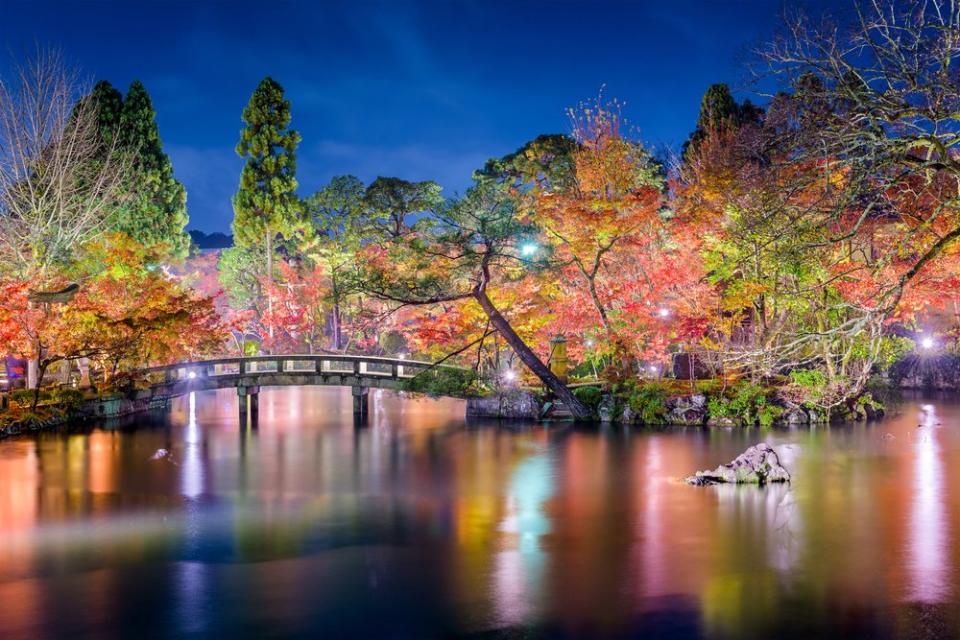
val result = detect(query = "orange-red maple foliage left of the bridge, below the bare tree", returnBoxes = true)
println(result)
[0,234,228,404]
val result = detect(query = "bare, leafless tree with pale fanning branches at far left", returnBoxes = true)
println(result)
[0,52,126,289]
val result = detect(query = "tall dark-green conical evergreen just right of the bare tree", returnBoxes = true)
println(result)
[114,80,190,257]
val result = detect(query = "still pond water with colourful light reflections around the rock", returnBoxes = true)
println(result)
[0,388,960,639]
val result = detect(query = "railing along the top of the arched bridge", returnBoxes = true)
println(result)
[144,353,462,382]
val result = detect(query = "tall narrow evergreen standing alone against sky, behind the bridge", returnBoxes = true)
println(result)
[233,77,304,280]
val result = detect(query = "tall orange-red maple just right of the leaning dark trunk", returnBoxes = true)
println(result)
[520,99,709,364]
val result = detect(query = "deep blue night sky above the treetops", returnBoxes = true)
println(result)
[0,0,827,232]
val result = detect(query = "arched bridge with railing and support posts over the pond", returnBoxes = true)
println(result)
[144,354,462,424]
